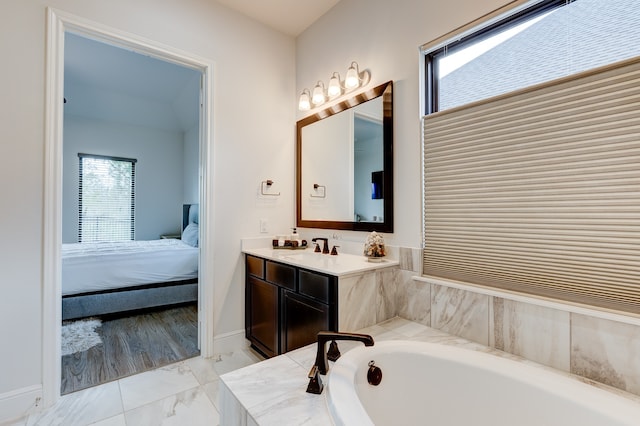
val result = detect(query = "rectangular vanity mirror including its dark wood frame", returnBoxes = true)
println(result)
[296,81,393,232]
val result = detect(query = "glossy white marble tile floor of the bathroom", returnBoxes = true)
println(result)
[1,349,262,426]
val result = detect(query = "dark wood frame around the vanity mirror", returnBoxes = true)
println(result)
[296,81,393,232]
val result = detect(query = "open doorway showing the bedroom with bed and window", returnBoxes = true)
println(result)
[61,32,202,395]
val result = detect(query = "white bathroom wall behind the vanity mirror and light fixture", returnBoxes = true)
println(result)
[296,0,509,247]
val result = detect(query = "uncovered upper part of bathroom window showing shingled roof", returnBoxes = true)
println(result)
[423,0,640,114]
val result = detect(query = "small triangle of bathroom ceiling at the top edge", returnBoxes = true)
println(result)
[216,0,340,37]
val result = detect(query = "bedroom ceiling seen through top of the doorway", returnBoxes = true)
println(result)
[64,33,200,132]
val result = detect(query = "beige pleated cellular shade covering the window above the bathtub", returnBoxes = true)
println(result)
[423,58,640,314]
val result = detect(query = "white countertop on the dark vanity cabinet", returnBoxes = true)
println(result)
[242,247,400,277]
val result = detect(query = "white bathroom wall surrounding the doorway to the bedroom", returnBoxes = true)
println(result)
[0,0,296,421]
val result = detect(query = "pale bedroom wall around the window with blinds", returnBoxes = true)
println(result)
[62,115,186,243]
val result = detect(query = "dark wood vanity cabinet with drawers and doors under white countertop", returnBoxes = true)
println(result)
[245,255,338,357]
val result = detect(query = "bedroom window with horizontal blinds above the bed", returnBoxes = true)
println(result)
[78,154,137,243]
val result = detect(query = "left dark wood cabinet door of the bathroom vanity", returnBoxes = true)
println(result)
[247,277,280,357]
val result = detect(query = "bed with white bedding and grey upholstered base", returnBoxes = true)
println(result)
[62,204,199,320]
